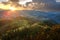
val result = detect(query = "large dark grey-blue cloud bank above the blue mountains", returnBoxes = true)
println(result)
[33,0,60,11]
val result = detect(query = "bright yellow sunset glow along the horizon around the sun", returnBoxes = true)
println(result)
[0,3,31,11]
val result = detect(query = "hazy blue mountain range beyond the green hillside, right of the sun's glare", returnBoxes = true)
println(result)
[19,10,60,24]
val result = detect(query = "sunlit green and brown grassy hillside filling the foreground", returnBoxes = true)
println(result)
[0,17,60,40]
